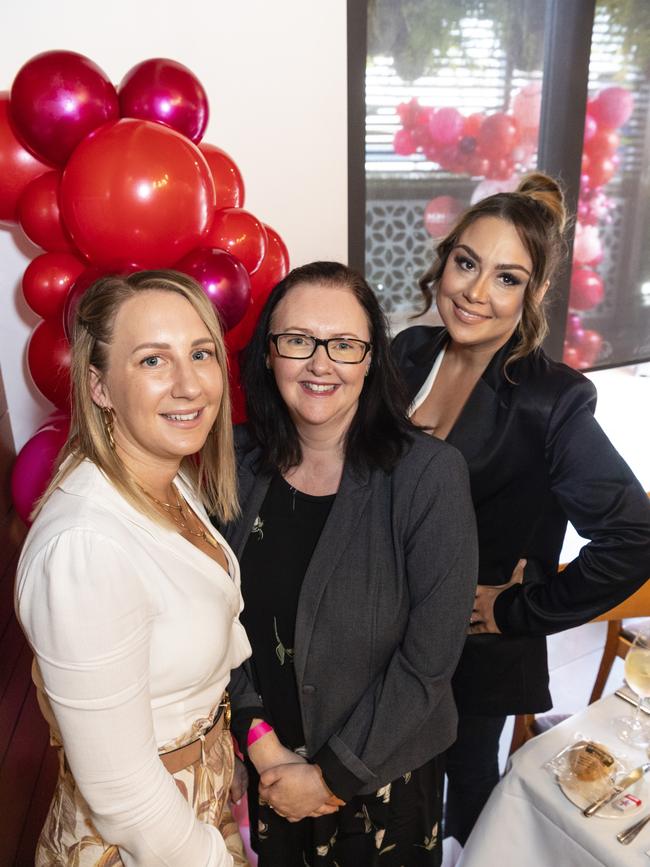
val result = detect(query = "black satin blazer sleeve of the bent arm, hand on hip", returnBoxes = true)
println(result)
[494,377,650,635]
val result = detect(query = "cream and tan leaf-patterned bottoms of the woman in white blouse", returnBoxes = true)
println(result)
[34,729,248,867]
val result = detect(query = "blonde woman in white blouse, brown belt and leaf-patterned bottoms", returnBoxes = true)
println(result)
[16,271,250,867]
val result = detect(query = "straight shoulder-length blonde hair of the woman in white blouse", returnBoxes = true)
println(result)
[32,270,239,524]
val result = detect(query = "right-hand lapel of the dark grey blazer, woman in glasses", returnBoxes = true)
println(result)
[294,465,371,684]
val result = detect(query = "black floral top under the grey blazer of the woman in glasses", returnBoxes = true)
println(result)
[241,473,336,749]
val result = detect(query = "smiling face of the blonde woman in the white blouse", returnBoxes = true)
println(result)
[91,290,223,479]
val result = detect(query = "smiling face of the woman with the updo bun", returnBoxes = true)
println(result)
[436,217,533,355]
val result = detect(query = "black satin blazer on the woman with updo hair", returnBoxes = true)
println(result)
[393,326,650,715]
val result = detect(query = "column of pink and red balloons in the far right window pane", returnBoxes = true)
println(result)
[563,87,634,368]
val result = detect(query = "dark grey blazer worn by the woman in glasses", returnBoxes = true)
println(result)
[222,429,477,801]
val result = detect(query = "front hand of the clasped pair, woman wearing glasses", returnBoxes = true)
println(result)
[259,764,332,822]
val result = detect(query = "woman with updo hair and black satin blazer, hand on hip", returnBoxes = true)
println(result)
[393,173,650,843]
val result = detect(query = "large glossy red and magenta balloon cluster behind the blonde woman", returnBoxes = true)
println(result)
[0,51,289,517]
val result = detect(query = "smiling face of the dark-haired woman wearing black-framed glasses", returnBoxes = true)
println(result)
[268,283,371,439]
